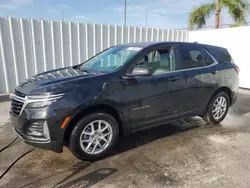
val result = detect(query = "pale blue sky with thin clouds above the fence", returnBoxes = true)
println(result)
[0,0,250,29]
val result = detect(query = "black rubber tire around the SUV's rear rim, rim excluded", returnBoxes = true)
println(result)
[206,92,230,124]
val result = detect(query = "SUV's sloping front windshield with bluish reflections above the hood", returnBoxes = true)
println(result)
[80,46,142,72]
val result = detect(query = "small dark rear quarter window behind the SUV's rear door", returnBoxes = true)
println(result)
[206,46,234,63]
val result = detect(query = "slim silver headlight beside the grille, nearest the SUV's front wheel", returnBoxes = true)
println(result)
[26,94,64,108]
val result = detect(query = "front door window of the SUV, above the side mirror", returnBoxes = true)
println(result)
[136,47,175,75]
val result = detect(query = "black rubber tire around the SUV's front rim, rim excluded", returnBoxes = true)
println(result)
[69,112,119,161]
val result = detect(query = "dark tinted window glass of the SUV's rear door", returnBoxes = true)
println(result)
[177,45,214,70]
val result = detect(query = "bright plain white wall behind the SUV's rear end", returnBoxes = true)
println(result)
[188,26,250,89]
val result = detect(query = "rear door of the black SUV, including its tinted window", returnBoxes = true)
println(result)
[176,44,217,117]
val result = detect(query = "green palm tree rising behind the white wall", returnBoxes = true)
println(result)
[188,0,249,29]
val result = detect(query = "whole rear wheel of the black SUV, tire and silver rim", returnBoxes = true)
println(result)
[203,92,230,124]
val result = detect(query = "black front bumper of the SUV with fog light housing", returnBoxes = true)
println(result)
[10,93,72,153]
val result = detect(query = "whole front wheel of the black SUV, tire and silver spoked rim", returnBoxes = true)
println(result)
[69,112,119,161]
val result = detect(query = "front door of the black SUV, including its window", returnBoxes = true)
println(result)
[126,46,181,130]
